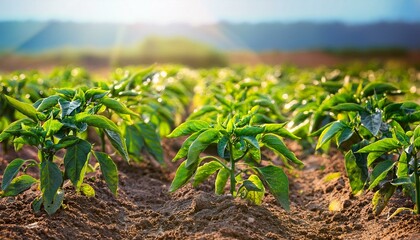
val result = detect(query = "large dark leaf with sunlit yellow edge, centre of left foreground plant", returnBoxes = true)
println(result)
[64,139,92,190]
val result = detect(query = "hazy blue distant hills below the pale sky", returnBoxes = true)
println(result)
[0,21,420,53]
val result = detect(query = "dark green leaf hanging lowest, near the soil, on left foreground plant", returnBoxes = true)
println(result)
[41,161,63,206]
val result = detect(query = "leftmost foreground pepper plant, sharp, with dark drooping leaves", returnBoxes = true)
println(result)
[0,89,129,214]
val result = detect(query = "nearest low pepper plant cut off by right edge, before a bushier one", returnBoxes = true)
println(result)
[357,125,420,217]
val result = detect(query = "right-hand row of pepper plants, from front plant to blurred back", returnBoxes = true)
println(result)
[274,64,420,217]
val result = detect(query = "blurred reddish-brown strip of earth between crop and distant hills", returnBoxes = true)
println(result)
[0,50,420,72]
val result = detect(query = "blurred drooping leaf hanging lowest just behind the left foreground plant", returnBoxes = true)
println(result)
[136,123,165,164]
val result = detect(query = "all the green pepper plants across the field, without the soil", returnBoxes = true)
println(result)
[0,66,420,218]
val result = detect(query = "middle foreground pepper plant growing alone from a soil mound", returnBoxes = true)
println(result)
[168,112,303,210]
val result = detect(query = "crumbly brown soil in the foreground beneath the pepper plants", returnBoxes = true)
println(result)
[0,140,420,240]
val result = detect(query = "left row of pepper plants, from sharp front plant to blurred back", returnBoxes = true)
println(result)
[0,67,191,214]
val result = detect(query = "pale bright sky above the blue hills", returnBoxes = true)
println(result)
[0,0,420,25]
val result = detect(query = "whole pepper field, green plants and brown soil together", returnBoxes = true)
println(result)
[0,64,420,239]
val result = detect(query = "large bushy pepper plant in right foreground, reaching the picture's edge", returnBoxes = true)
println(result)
[314,94,420,215]
